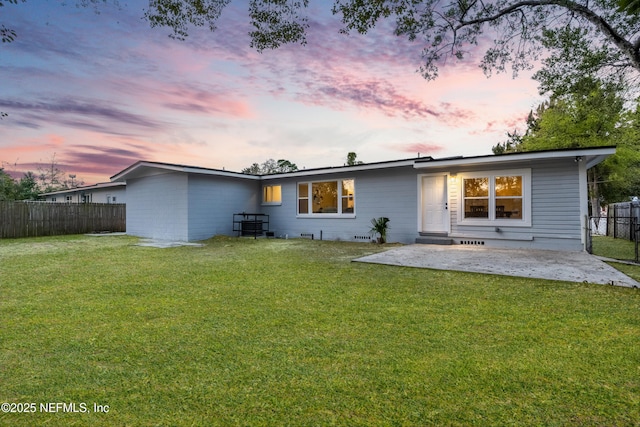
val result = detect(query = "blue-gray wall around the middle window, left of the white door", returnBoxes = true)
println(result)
[260,166,418,243]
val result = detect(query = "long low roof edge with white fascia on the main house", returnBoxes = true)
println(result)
[111,147,616,182]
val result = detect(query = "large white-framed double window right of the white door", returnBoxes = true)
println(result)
[458,169,531,226]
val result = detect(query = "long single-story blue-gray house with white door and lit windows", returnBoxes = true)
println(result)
[111,147,615,251]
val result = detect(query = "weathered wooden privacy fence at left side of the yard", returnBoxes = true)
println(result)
[0,202,126,238]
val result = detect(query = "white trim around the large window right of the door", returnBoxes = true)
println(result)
[457,169,531,227]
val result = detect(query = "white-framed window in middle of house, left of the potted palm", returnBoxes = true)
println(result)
[298,179,356,216]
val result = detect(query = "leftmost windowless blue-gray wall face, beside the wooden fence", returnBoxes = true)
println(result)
[127,173,189,240]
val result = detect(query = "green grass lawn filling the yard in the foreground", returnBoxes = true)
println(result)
[0,236,640,426]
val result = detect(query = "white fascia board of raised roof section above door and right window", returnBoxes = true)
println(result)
[414,147,616,169]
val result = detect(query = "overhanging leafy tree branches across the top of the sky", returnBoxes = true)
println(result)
[145,0,640,91]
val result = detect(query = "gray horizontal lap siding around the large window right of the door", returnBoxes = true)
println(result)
[440,159,582,250]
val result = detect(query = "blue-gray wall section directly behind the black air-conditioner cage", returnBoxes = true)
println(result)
[188,175,261,240]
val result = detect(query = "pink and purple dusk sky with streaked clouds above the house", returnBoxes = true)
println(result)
[0,0,542,184]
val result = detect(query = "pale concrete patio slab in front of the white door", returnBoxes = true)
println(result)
[354,245,640,288]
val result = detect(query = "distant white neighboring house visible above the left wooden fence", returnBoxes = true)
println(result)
[42,182,127,203]
